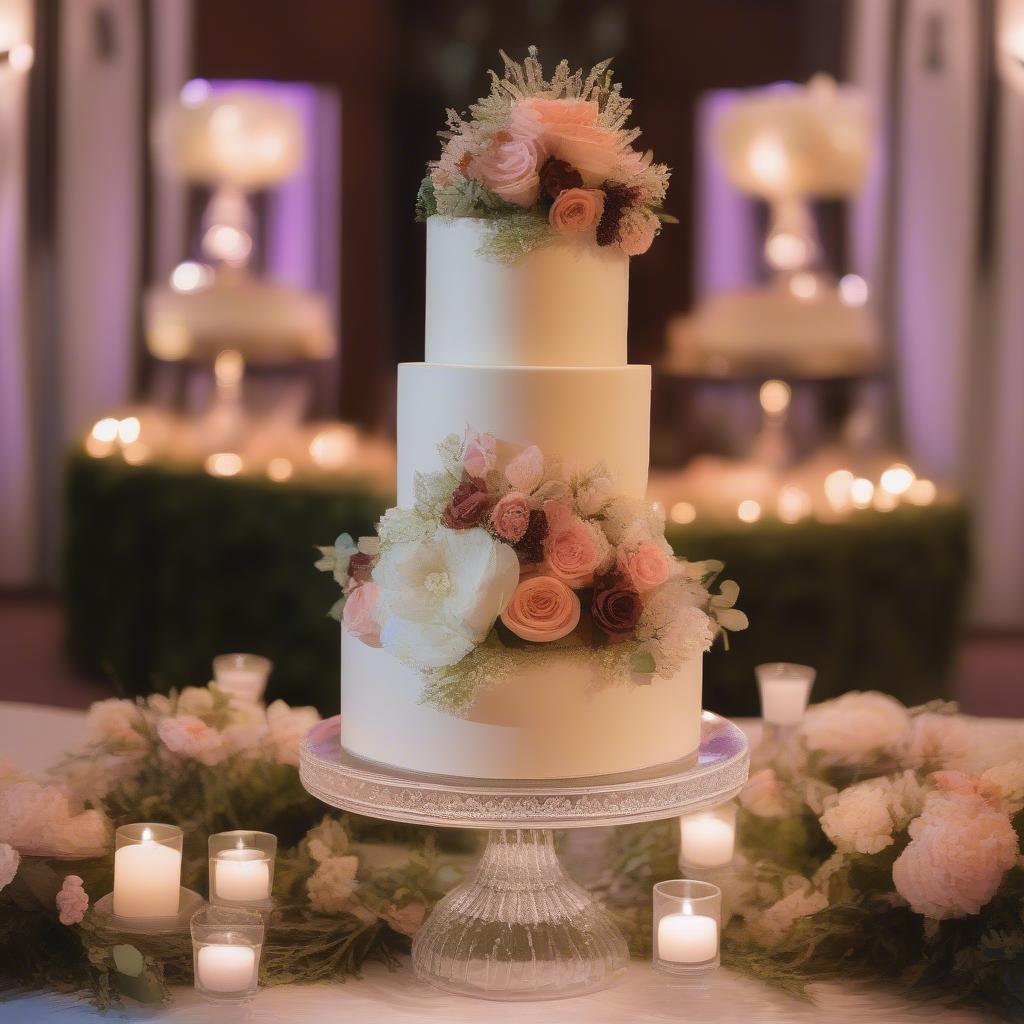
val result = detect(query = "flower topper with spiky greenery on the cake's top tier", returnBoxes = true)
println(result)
[417,47,674,261]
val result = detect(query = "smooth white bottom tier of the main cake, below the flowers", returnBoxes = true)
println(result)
[341,630,701,779]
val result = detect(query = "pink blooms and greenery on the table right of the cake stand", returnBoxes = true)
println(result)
[598,692,1024,1020]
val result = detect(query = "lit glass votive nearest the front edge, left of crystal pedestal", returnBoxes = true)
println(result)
[191,906,264,1002]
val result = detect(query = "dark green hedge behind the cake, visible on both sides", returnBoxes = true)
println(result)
[65,453,968,715]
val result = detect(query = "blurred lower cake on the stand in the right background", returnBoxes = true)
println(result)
[667,285,880,377]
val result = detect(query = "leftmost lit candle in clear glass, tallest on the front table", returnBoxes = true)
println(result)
[113,821,184,921]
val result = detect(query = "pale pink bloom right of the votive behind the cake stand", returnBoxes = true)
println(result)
[801,691,910,764]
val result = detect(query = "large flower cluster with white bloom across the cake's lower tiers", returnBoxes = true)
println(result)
[316,430,746,714]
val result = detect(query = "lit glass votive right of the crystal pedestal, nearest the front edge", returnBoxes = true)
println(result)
[653,879,722,978]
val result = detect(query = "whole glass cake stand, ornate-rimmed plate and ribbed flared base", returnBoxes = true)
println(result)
[299,711,750,999]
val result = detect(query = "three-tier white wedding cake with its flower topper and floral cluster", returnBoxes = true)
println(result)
[317,51,745,779]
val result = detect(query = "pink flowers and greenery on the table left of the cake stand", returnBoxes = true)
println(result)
[0,684,456,1007]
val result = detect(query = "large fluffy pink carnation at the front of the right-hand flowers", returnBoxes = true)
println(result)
[893,792,1019,921]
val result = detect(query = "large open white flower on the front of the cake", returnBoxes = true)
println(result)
[374,526,519,670]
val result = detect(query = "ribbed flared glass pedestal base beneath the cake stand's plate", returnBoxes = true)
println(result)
[413,828,629,999]
